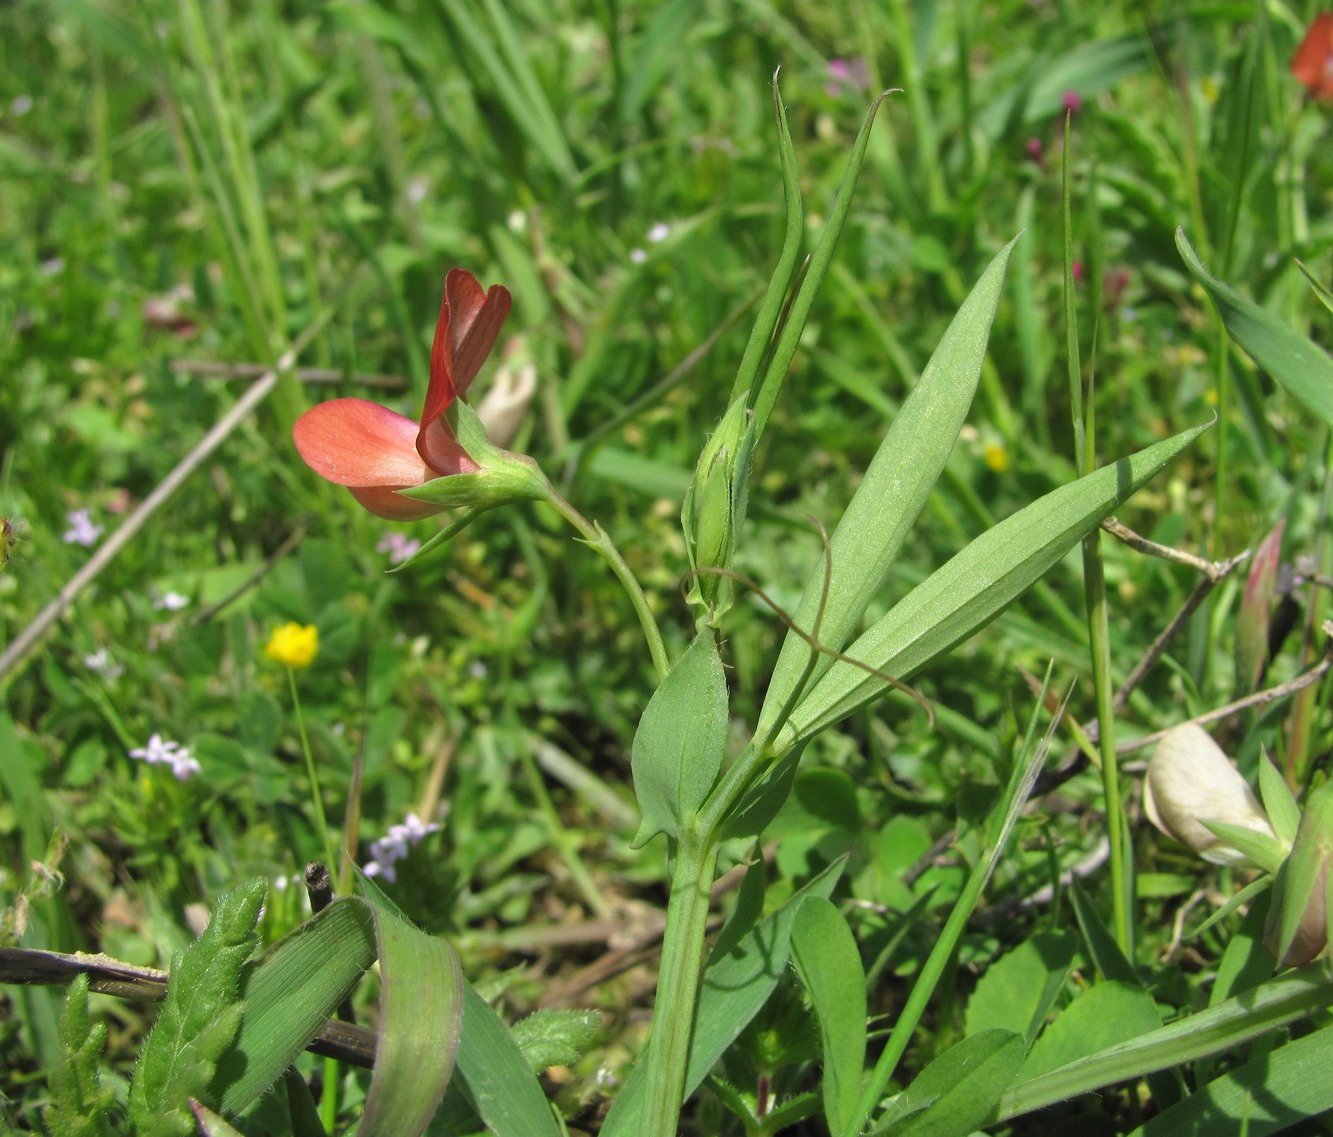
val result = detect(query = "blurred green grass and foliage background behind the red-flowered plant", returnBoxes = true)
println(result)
[0,0,1333,1118]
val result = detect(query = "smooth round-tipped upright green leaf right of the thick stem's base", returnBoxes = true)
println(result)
[792,896,863,1133]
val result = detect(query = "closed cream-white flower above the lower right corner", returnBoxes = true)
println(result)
[1144,722,1277,865]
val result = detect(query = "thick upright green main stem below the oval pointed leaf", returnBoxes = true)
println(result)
[641,830,717,1137]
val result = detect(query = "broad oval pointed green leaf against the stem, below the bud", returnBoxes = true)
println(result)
[631,628,726,845]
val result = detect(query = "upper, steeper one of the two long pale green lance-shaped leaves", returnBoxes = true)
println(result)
[756,237,1017,736]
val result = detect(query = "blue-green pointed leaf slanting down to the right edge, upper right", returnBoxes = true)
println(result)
[1176,229,1333,427]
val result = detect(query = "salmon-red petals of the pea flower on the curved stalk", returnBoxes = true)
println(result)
[292,268,511,521]
